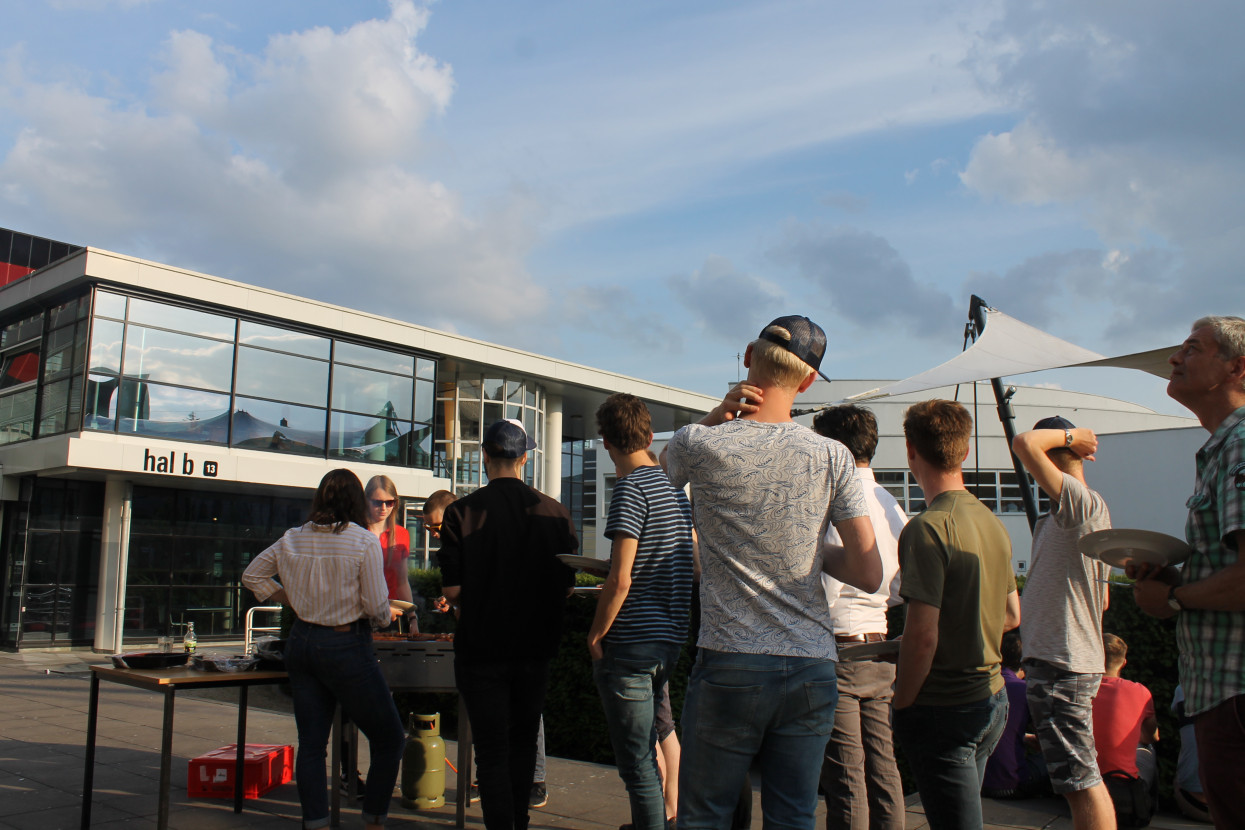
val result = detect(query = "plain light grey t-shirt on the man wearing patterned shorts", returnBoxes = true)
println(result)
[1020,473,1111,674]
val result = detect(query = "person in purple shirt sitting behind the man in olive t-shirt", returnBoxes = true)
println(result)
[981,628,1051,799]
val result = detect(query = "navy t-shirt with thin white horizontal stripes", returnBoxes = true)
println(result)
[605,467,692,643]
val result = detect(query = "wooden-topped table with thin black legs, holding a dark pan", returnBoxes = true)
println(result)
[81,666,289,830]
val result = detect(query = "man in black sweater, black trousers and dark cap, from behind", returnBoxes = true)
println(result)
[438,419,579,830]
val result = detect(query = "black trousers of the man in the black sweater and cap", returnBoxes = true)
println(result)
[454,657,549,830]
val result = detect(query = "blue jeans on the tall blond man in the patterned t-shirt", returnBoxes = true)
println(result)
[679,648,838,830]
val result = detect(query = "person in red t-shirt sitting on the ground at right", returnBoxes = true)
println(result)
[1093,633,1159,828]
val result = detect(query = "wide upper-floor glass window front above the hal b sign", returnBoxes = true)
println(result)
[67,291,437,468]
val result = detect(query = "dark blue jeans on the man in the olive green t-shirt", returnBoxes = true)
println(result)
[893,689,1007,830]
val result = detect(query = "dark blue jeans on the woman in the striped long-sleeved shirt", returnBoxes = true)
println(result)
[285,620,406,829]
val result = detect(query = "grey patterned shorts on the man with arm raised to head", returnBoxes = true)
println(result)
[1025,660,1102,793]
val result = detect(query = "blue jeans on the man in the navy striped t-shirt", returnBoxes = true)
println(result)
[593,642,681,830]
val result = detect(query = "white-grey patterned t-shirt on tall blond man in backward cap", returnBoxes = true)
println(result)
[666,421,869,660]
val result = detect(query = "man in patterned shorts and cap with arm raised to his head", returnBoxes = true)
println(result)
[1012,416,1116,830]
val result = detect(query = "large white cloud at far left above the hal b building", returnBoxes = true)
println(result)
[0,0,549,333]
